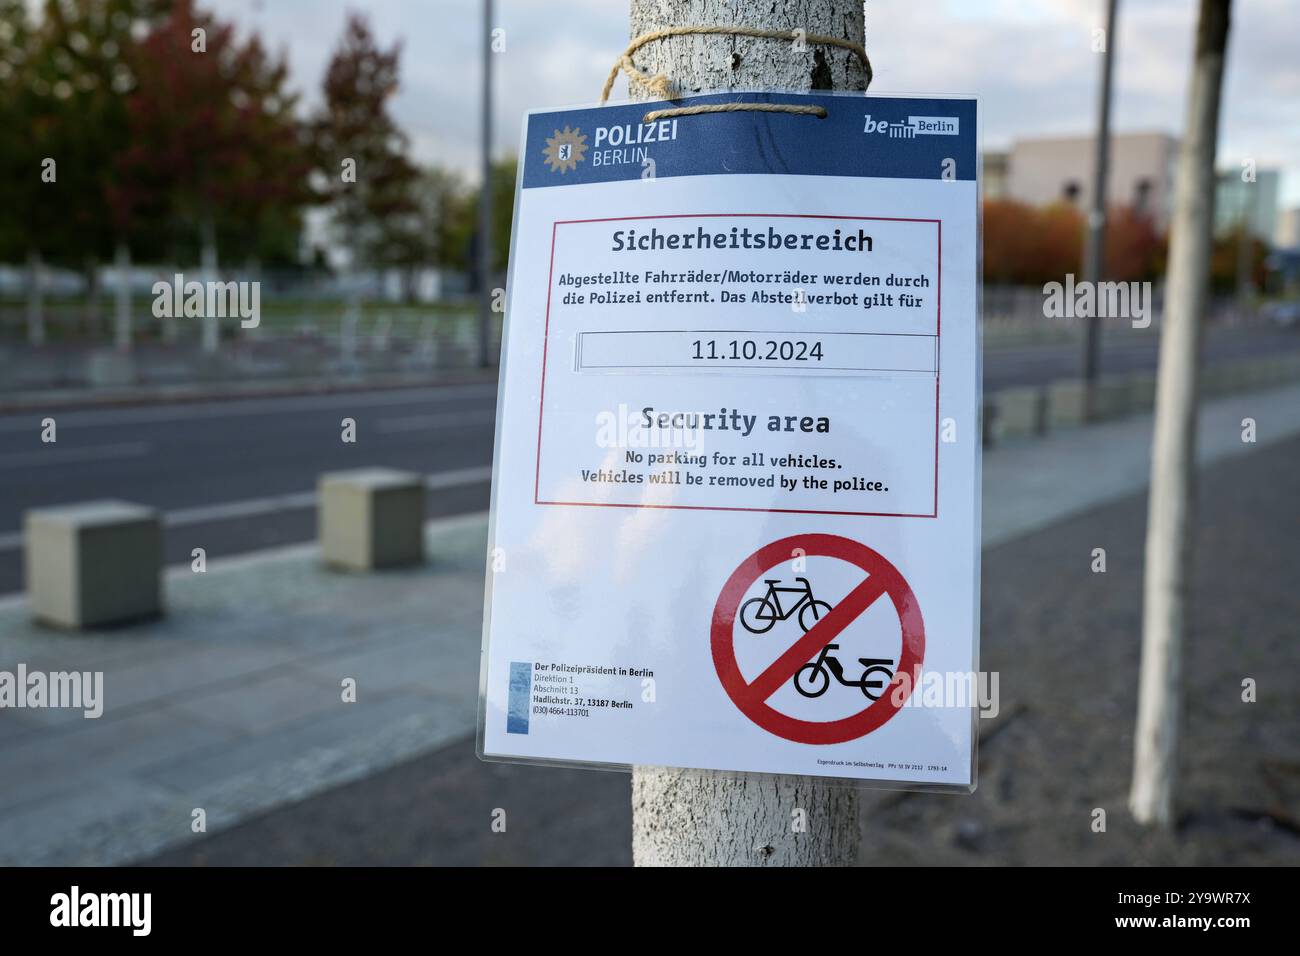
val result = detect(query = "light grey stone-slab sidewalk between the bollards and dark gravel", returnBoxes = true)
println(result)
[0,386,1300,864]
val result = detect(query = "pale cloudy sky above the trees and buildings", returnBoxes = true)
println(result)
[218,0,1300,207]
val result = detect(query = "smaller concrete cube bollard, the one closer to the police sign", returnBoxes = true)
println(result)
[316,468,424,571]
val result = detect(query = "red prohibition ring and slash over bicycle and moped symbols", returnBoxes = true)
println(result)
[712,535,926,744]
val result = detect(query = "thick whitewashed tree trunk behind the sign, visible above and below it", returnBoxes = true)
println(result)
[631,0,866,866]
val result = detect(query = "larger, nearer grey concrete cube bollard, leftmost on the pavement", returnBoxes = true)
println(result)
[23,501,163,628]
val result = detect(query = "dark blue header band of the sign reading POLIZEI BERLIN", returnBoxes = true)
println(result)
[523,92,978,189]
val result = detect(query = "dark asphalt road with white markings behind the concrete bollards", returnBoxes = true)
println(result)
[0,323,1300,593]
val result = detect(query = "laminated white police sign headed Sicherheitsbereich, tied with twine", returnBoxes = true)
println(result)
[478,94,982,788]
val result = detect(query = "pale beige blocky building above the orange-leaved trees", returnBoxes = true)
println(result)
[1006,133,1178,229]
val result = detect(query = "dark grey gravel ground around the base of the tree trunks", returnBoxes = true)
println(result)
[146,438,1300,866]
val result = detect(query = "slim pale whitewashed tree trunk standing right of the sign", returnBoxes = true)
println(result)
[1128,0,1230,826]
